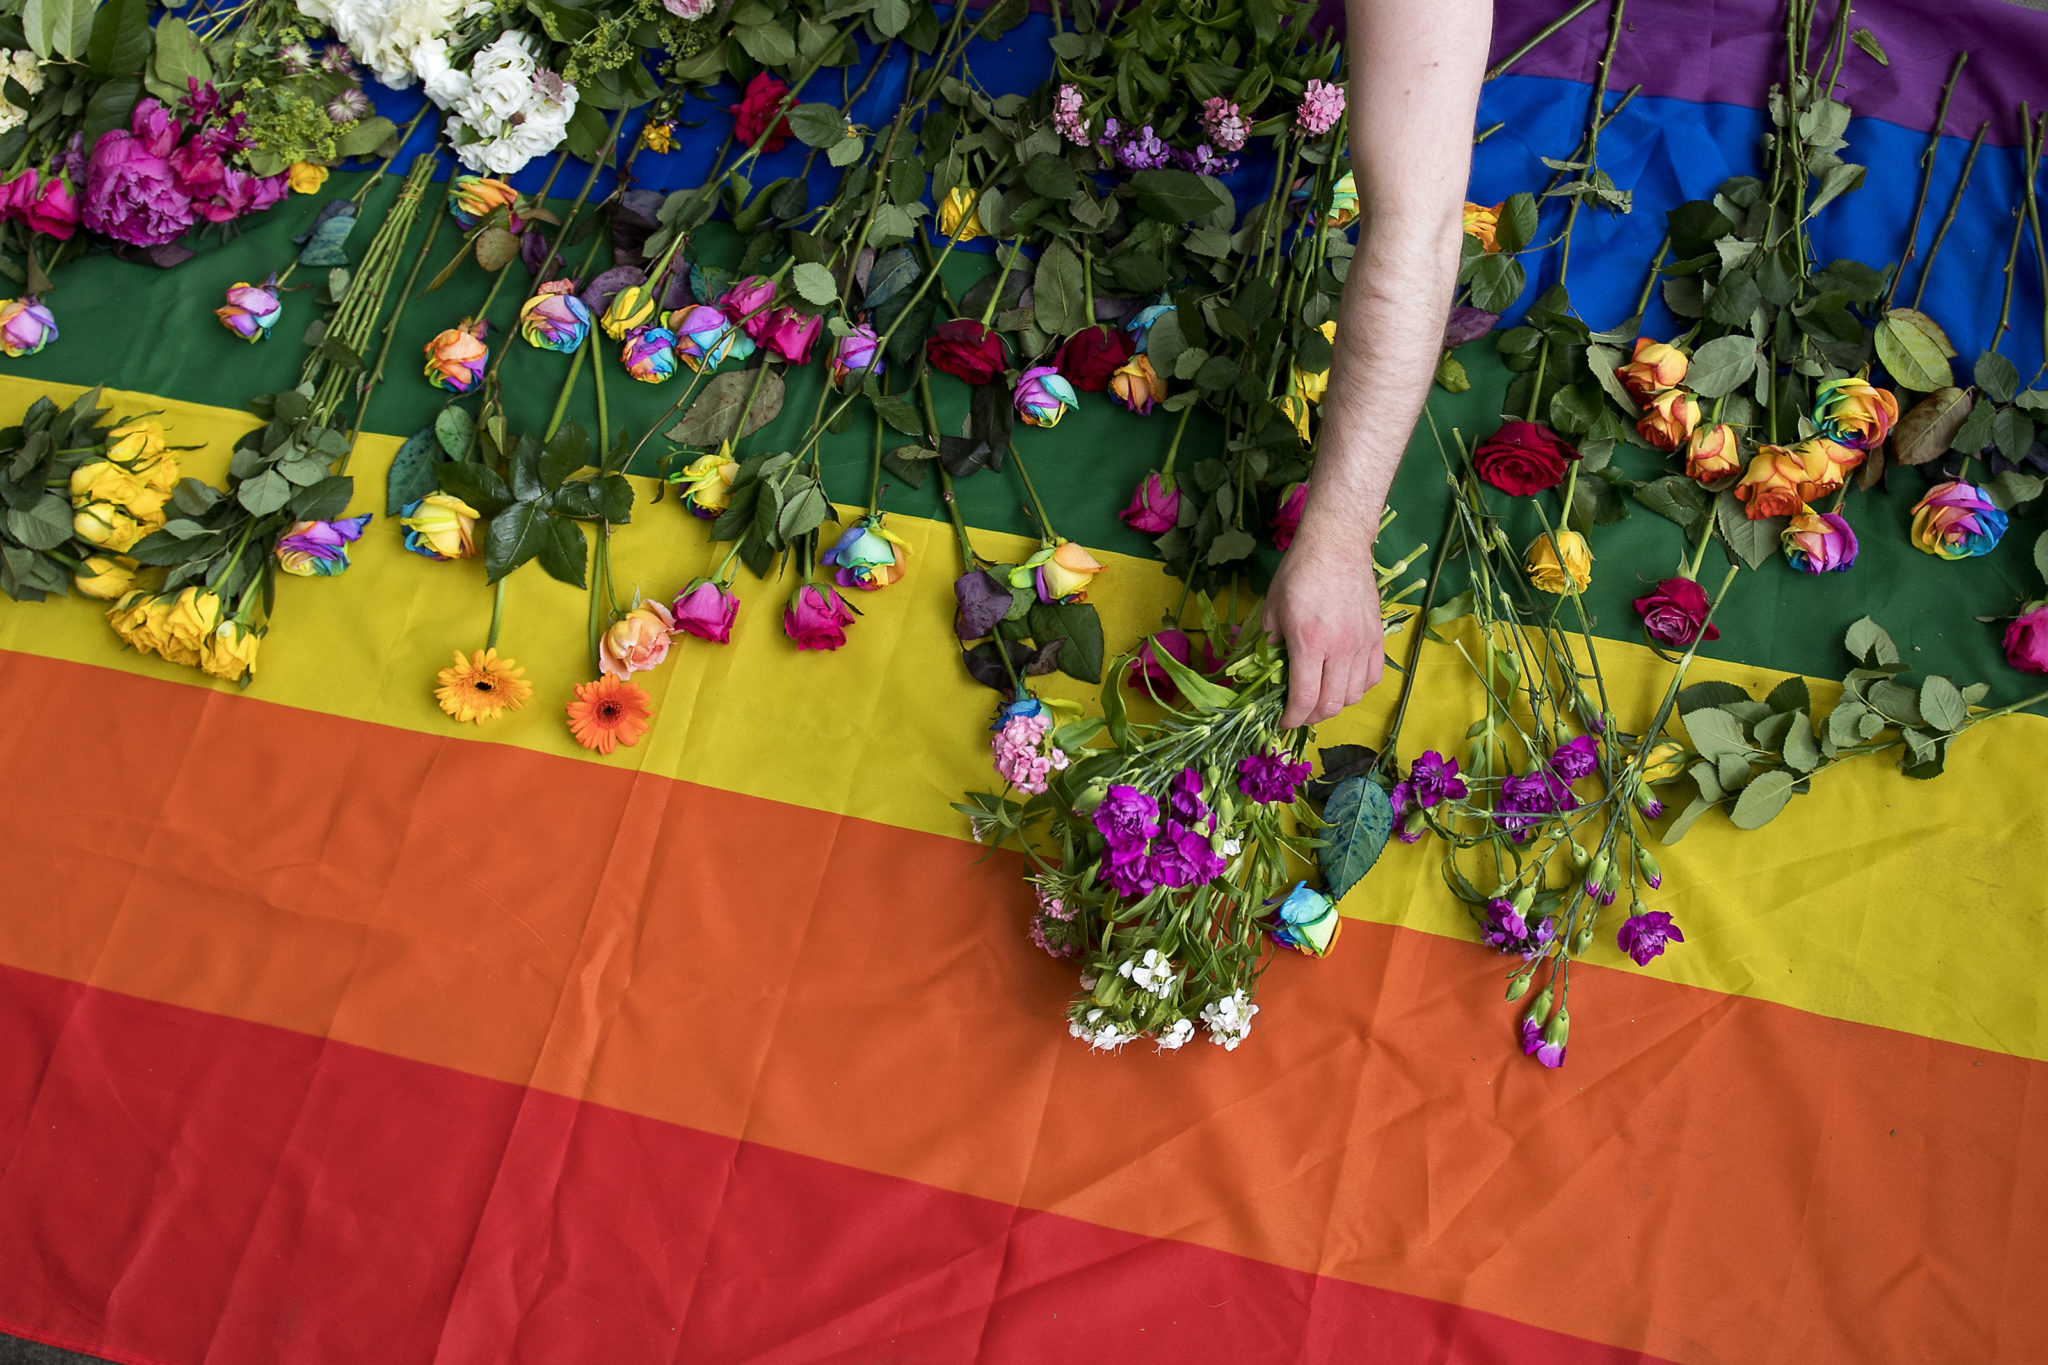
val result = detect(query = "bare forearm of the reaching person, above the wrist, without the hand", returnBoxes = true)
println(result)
[1303,0,1491,559]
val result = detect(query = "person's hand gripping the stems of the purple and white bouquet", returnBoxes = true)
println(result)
[1266,524,1382,729]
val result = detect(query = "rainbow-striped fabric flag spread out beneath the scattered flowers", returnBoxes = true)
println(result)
[0,0,2048,1365]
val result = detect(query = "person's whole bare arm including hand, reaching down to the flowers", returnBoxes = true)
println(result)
[1266,0,1493,726]
